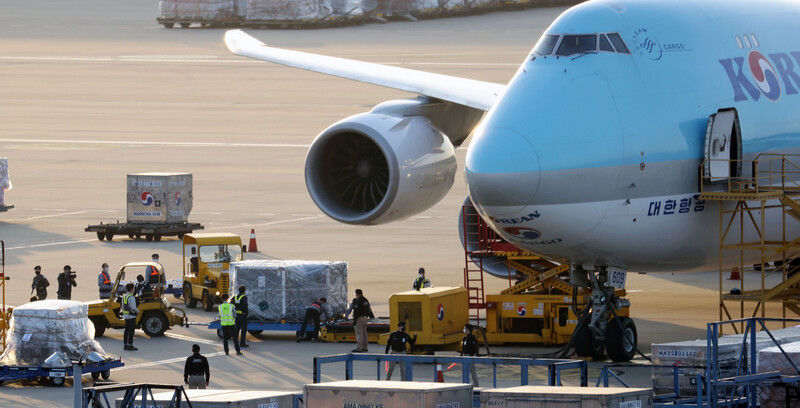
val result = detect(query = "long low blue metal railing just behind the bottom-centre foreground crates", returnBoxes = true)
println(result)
[314,354,588,388]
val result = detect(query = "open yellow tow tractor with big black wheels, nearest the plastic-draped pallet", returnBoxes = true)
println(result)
[86,262,188,337]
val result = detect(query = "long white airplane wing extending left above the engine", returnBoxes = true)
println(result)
[225,30,506,111]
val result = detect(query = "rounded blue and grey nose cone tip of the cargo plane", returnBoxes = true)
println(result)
[464,128,541,214]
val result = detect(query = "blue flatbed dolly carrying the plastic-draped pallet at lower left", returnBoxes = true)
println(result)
[0,359,125,387]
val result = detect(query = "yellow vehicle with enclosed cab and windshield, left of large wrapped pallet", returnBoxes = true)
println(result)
[182,233,243,312]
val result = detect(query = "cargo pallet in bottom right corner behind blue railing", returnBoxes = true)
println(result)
[758,342,800,408]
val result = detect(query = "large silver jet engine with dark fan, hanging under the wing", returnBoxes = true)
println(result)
[305,100,457,225]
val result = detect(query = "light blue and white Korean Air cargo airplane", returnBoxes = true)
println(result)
[225,0,800,360]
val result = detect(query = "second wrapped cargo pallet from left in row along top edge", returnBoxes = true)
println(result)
[245,0,333,21]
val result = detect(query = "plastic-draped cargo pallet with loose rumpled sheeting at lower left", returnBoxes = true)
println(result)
[0,300,112,367]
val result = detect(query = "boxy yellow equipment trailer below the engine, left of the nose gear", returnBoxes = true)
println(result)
[378,287,469,354]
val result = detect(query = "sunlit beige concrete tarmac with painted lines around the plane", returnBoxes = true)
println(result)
[0,0,776,407]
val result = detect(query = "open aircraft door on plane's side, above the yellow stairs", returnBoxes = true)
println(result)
[703,109,742,182]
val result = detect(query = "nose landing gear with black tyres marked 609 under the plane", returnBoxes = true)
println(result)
[570,266,638,362]
